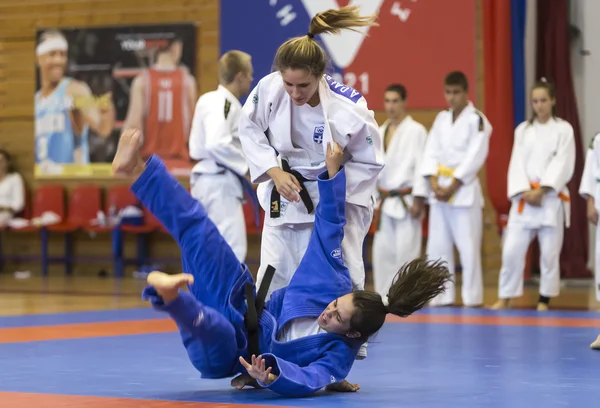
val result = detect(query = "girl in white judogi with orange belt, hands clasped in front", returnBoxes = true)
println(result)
[492,80,575,311]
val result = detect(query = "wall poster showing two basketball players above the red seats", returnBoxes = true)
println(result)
[35,23,197,178]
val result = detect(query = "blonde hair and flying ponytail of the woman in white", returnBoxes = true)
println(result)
[274,6,377,77]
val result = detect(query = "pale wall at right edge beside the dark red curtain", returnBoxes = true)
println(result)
[571,0,600,267]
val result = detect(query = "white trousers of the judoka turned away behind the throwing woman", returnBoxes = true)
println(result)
[191,171,248,263]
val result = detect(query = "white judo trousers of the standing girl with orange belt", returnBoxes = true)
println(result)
[498,211,564,299]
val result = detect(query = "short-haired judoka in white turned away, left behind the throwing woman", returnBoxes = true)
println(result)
[190,50,255,262]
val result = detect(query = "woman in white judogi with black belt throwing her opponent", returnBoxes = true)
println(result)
[239,7,383,357]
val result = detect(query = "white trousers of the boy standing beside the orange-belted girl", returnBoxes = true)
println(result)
[427,202,483,306]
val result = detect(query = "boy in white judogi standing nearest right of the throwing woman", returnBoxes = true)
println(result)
[373,85,427,302]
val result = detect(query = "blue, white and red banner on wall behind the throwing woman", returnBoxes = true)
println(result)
[220,0,476,109]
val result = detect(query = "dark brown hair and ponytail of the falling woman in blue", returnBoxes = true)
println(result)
[350,257,452,341]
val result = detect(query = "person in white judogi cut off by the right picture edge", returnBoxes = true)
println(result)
[579,133,600,350]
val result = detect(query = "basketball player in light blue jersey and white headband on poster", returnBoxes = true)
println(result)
[35,31,115,168]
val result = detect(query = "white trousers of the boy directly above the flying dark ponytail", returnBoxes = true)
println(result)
[373,212,423,305]
